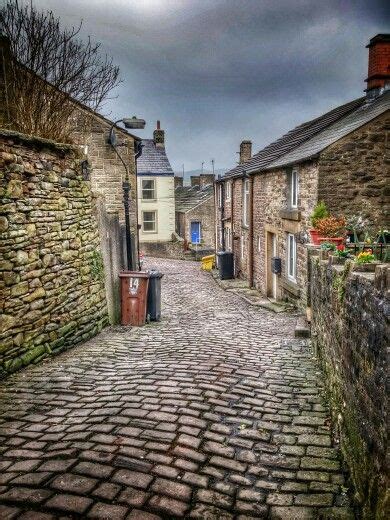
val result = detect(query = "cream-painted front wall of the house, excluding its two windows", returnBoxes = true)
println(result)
[137,175,175,242]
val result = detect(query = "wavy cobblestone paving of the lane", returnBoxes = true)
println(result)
[0,260,354,520]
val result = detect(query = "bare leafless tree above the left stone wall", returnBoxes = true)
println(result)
[0,0,119,141]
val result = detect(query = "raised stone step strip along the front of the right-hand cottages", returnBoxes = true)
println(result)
[211,269,295,314]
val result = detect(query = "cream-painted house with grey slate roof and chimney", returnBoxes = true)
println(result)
[137,121,175,251]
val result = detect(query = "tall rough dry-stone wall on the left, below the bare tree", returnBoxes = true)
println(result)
[0,131,107,376]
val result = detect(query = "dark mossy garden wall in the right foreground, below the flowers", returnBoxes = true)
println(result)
[310,252,390,519]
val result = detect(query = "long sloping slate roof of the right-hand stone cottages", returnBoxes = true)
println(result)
[222,93,390,179]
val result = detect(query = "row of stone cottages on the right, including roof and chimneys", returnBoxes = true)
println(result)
[216,35,390,306]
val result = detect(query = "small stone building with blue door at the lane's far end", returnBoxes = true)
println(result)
[175,174,215,250]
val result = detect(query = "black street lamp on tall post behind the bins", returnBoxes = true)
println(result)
[108,116,145,271]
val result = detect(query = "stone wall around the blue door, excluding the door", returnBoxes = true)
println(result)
[180,196,215,249]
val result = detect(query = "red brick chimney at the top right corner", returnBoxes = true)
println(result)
[365,34,390,98]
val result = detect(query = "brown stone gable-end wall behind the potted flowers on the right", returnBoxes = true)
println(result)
[318,111,390,229]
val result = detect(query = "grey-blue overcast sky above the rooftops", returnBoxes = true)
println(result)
[34,0,390,170]
